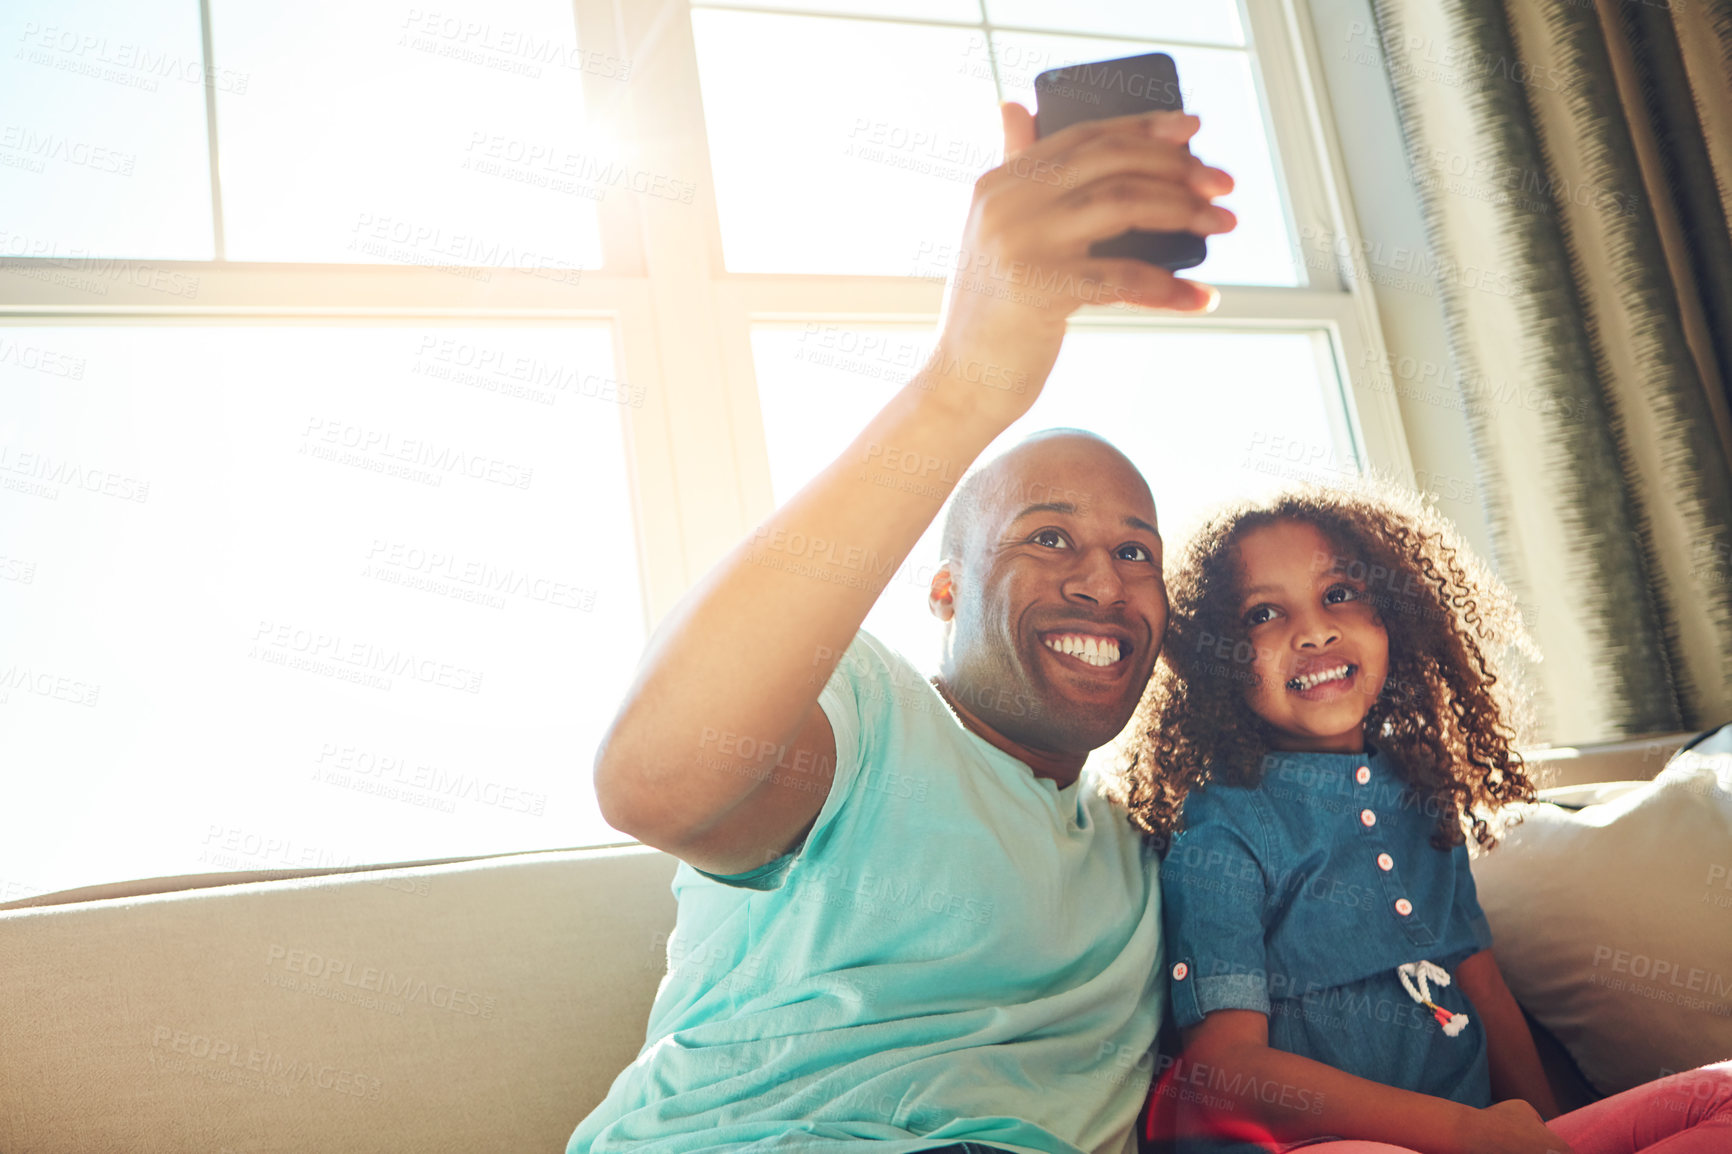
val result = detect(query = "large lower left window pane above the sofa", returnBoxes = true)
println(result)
[0,324,644,880]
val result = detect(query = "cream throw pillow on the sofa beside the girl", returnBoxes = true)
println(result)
[1474,752,1732,1093]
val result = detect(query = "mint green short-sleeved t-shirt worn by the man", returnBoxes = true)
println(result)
[566,632,1166,1154]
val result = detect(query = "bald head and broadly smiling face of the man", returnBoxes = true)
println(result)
[932,433,1167,766]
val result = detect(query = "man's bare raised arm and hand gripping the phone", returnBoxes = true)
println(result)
[596,104,1233,873]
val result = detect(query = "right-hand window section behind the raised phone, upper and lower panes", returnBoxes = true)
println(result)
[693,0,1406,671]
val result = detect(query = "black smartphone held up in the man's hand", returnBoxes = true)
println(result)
[1034,52,1209,272]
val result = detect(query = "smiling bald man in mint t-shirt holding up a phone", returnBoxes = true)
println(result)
[568,104,1233,1154]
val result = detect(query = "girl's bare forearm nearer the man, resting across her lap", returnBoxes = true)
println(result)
[1169,1003,1569,1154]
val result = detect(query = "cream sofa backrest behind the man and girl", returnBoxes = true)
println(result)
[0,735,1682,1154]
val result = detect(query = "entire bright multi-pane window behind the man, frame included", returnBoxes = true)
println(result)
[0,0,1406,901]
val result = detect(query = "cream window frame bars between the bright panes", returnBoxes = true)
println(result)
[0,0,1413,631]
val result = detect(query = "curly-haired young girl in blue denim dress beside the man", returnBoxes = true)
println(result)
[1119,490,1732,1154]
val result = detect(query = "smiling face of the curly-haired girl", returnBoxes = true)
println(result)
[1238,522,1389,754]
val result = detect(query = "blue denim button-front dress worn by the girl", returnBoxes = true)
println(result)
[1160,750,1491,1151]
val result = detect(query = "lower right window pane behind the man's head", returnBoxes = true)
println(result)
[753,324,1360,672]
